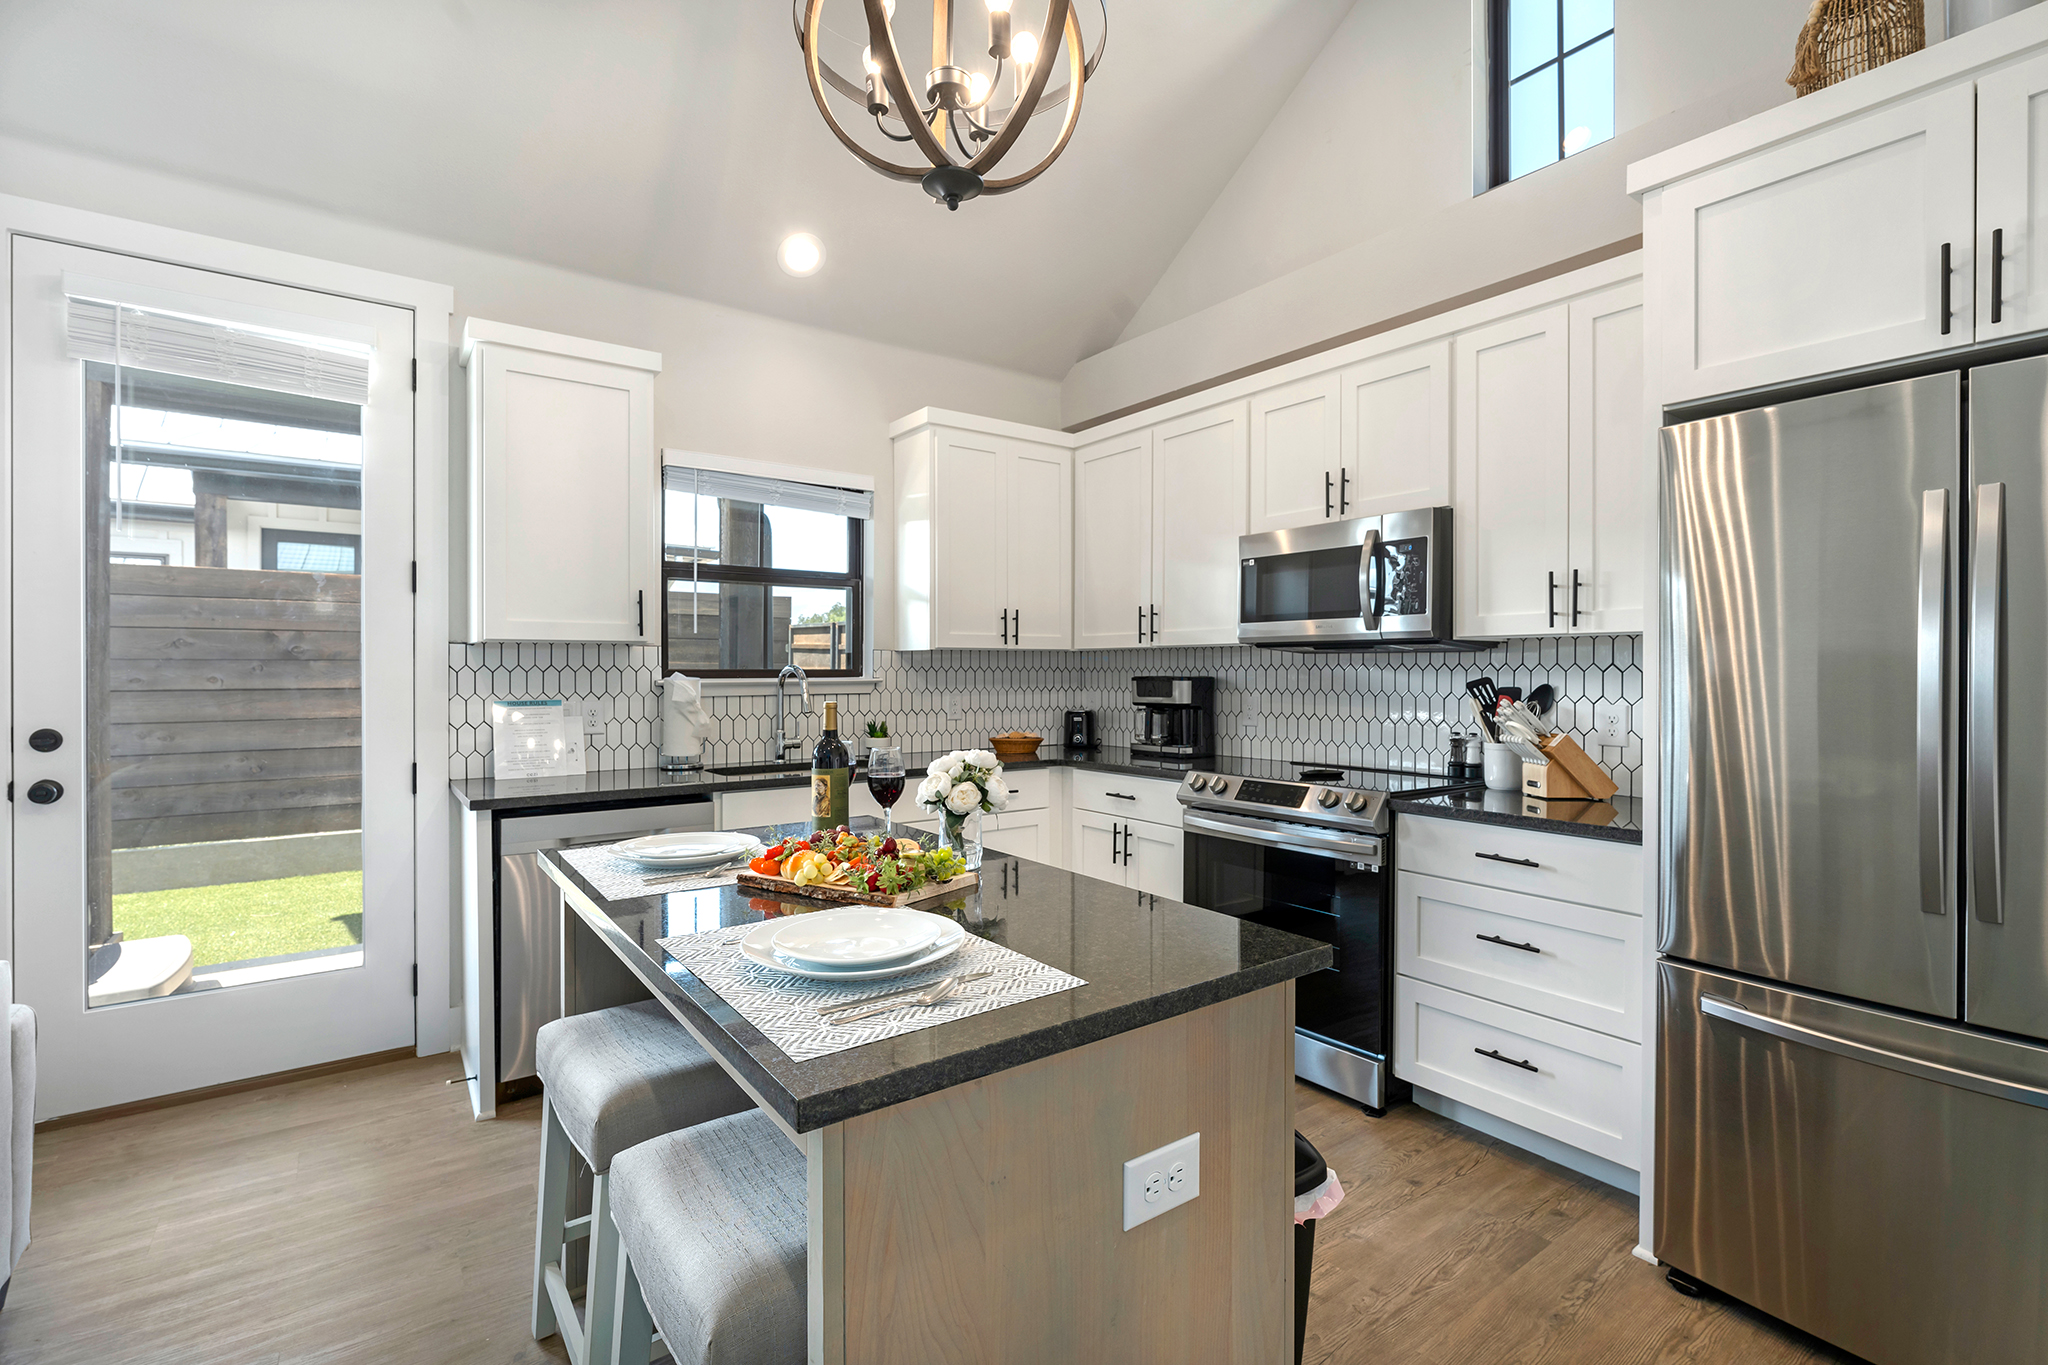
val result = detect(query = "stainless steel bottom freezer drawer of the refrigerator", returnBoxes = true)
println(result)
[1655,962,2048,1365]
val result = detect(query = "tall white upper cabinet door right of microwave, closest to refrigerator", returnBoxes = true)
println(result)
[1565,280,1657,634]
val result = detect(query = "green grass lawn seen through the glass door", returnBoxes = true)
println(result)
[115,872,362,966]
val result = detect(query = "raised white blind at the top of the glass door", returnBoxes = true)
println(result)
[66,295,371,407]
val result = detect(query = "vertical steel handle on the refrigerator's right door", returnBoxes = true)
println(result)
[1968,483,2005,925]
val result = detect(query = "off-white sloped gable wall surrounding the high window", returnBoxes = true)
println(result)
[1061,0,1818,426]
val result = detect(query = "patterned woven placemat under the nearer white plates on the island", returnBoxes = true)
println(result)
[662,925,1087,1062]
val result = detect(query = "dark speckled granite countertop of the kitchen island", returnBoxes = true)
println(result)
[541,821,1333,1132]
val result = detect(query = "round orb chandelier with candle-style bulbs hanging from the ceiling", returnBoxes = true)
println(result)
[793,0,1110,211]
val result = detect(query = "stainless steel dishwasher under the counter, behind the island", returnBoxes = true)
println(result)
[496,796,713,1103]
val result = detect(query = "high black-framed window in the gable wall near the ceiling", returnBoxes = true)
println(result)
[1487,0,1614,184]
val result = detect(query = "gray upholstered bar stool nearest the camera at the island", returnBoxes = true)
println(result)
[612,1109,809,1365]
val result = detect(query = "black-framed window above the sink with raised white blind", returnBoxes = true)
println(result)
[662,465,874,677]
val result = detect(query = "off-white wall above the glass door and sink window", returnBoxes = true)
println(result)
[0,137,1059,654]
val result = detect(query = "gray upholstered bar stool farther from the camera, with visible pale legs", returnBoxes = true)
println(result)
[532,1001,749,1365]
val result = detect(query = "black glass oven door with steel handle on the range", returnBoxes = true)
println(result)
[1182,810,1393,1062]
